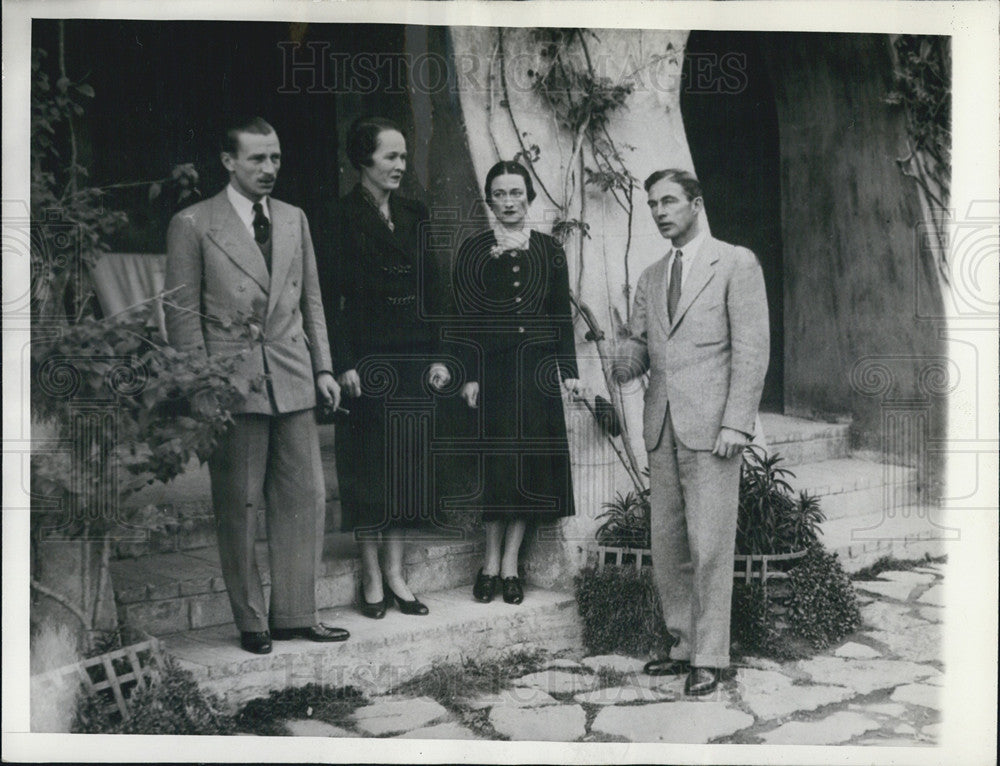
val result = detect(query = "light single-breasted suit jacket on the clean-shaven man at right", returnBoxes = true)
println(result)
[616,237,770,451]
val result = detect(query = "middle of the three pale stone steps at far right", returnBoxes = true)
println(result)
[787,458,920,520]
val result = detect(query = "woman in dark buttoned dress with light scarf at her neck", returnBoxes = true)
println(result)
[452,162,579,604]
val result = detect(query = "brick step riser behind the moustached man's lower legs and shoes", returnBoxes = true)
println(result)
[111,532,483,636]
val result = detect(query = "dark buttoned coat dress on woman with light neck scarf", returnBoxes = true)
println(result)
[452,231,578,521]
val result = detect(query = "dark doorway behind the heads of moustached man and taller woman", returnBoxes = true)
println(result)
[32,20,422,253]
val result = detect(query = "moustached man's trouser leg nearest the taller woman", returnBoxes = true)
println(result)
[264,410,326,628]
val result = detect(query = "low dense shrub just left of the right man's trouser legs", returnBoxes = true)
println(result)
[574,566,673,656]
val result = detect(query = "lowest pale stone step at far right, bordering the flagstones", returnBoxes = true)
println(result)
[821,505,948,572]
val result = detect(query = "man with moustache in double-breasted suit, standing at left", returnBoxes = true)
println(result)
[165,117,348,654]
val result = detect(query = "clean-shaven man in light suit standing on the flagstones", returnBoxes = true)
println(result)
[615,169,769,696]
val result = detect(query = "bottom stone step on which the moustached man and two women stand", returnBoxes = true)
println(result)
[162,587,582,706]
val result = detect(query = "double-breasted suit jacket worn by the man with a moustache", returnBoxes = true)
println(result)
[164,189,333,414]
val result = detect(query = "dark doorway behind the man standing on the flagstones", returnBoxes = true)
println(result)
[681,31,784,412]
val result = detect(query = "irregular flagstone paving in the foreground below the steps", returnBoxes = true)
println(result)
[276,564,943,746]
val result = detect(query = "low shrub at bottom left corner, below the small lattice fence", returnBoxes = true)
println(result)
[72,657,234,734]
